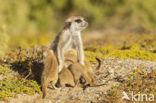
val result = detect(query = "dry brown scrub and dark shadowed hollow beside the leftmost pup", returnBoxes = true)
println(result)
[2,46,44,80]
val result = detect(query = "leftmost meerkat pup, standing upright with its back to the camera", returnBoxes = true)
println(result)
[41,49,58,98]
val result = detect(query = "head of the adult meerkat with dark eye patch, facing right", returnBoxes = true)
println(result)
[66,16,88,31]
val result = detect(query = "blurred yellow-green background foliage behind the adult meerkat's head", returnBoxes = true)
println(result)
[0,0,156,54]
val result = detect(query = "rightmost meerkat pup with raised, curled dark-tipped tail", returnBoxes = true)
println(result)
[68,58,101,86]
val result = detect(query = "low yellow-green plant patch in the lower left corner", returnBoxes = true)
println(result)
[0,78,41,100]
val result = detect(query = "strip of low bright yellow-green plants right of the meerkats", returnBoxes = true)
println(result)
[85,44,156,61]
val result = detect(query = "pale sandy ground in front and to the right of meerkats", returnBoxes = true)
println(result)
[0,58,156,103]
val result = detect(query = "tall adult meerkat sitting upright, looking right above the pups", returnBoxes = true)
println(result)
[50,16,88,72]
